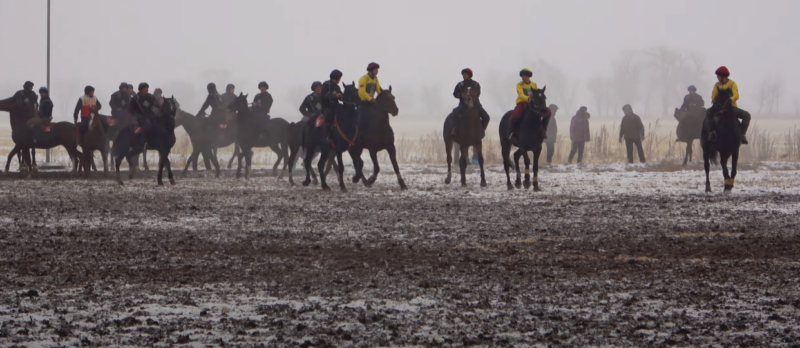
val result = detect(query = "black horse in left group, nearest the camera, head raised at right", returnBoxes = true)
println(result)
[111,97,180,185]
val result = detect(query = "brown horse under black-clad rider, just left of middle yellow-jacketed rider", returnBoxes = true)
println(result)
[442,88,487,187]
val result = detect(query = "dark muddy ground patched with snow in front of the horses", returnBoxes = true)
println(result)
[0,165,800,347]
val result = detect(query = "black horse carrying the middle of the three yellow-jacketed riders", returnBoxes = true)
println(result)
[500,87,549,191]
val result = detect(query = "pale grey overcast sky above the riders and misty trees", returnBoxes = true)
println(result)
[0,0,800,120]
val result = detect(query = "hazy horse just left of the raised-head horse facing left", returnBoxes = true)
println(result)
[175,110,227,178]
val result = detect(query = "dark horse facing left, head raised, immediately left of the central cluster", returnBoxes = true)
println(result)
[229,93,289,179]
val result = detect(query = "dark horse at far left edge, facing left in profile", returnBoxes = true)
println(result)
[0,96,81,176]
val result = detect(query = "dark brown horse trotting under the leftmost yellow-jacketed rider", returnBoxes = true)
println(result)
[353,86,408,190]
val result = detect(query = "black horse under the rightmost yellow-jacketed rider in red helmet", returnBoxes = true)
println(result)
[700,92,742,193]
